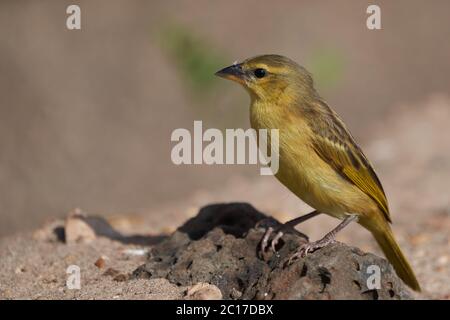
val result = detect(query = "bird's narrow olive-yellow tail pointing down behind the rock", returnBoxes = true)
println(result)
[371,221,420,291]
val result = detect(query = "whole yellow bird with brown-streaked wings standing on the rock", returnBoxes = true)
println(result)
[216,55,420,291]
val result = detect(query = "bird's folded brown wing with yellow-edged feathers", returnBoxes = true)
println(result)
[308,101,391,222]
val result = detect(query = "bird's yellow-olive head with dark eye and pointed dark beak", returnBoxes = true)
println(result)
[216,54,315,100]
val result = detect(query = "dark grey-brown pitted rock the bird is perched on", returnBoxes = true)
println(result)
[133,203,411,299]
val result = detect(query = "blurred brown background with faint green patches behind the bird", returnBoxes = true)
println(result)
[0,0,450,235]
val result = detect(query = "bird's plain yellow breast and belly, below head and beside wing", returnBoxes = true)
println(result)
[250,101,372,218]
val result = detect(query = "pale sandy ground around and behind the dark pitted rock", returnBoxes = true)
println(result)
[0,96,450,299]
